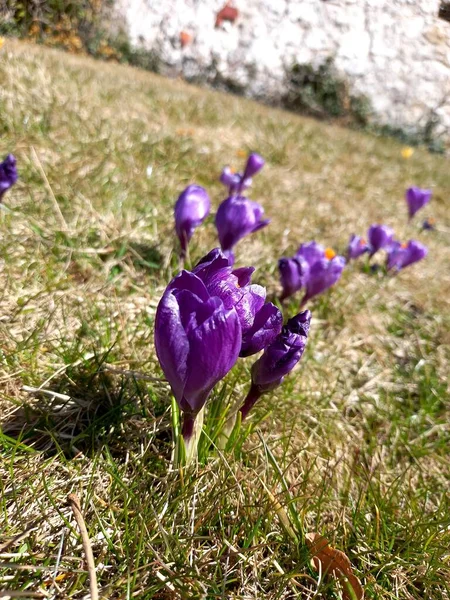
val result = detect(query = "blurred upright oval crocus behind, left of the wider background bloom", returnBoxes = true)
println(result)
[175,185,211,256]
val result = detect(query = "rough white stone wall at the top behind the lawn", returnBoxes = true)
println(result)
[116,0,450,136]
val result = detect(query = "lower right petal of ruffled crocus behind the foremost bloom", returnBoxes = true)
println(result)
[240,302,283,357]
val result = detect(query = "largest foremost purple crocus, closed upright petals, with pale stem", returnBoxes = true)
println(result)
[155,270,242,457]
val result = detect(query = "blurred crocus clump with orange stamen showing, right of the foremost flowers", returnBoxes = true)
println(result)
[278,241,345,305]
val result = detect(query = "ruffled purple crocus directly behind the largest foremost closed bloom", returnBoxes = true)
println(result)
[193,248,283,356]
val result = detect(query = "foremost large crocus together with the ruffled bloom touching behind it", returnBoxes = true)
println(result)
[155,249,298,461]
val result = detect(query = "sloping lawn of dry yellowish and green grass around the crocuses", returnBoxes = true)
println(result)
[0,41,450,600]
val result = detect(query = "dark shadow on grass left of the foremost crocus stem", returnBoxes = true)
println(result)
[1,365,171,458]
